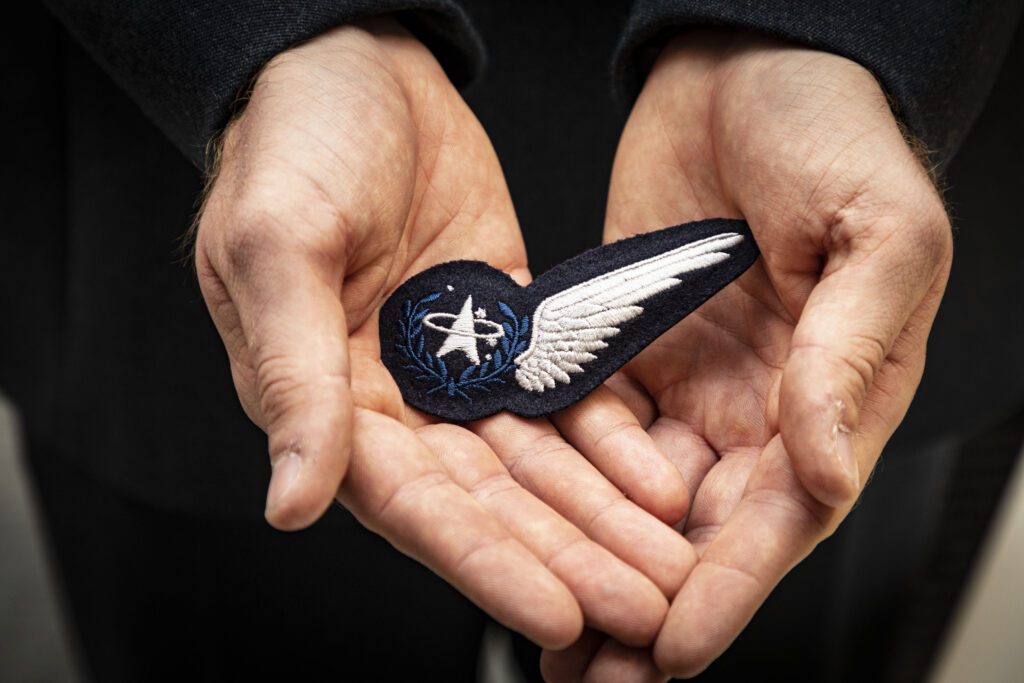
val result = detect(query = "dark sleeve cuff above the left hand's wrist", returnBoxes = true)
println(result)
[45,0,483,167]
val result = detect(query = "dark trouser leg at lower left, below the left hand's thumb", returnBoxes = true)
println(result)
[33,448,484,682]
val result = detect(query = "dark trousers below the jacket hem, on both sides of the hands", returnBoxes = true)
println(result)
[25,412,1024,683]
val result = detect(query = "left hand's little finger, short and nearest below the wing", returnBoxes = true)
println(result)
[551,386,689,524]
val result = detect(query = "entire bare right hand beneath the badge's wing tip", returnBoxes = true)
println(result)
[542,30,951,682]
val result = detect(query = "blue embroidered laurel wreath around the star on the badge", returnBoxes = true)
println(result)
[395,292,529,402]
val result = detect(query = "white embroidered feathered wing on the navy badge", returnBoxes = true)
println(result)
[515,232,743,392]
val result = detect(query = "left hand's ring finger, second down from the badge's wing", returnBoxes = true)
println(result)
[472,414,696,596]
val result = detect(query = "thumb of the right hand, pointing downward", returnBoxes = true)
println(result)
[779,200,949,506]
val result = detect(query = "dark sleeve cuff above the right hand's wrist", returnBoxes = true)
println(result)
[612,0,1024,165]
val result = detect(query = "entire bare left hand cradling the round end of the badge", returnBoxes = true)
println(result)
[196,20,696,648]
